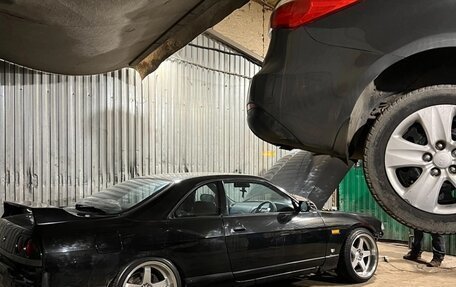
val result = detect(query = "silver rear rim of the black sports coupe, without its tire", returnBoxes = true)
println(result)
[122,261,177,287]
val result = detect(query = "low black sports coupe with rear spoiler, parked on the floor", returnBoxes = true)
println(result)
[0,174,382,287]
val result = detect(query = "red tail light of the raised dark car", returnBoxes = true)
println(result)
[271,0,360,29]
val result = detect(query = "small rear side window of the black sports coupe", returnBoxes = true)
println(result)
[174,183,220,217]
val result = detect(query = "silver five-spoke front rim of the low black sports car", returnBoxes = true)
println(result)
[350,233,378,278]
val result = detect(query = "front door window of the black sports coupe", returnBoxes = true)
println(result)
[223,182,294,215]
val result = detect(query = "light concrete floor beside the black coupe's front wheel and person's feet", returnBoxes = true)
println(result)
[261,243,456,287]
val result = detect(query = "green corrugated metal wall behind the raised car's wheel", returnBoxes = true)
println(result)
[339,164,456,255]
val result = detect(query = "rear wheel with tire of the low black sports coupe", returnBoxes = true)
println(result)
[115,258,181,287]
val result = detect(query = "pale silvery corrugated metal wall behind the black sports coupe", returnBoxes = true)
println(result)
[0,33,284,210]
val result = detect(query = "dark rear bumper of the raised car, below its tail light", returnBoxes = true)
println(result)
[248,27,377,156]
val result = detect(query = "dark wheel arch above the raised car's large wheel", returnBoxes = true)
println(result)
[345,47,456,159]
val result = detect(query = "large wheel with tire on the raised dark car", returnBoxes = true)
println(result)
[364,85,456,234]
